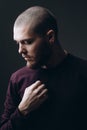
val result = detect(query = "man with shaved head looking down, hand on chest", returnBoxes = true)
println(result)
[0,6,87,130]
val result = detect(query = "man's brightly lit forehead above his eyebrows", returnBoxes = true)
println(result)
[13,25,34,41]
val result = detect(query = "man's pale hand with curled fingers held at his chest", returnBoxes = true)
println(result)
[18,81,48,115]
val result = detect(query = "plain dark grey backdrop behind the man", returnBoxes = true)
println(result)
[0,0,87,117]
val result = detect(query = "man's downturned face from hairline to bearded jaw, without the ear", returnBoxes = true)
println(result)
[14,26,51,69]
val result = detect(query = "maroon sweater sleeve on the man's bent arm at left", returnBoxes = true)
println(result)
[0,75,28,130]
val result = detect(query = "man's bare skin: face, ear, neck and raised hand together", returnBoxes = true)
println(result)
[14,25,65,116]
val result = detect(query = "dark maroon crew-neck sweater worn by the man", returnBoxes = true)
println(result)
[0,54,87,130]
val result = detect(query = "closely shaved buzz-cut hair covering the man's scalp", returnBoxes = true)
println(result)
[14,6,58,37]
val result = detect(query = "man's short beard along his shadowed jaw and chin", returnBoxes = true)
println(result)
[27,44,52,69]
